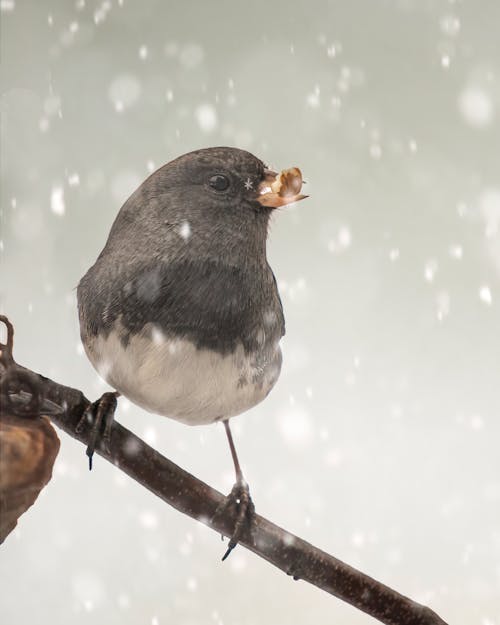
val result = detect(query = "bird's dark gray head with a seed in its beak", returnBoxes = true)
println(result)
[112,147,306,255]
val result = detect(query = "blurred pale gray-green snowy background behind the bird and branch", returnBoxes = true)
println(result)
[0,0,500,625]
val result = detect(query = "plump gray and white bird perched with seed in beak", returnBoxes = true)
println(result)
[77,147,307,559]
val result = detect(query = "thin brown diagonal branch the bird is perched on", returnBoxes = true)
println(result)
[0,315,446,625]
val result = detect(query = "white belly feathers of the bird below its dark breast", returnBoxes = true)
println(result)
[84,324,281,425]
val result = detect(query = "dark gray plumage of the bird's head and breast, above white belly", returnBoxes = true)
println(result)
[78,148,285,354]
